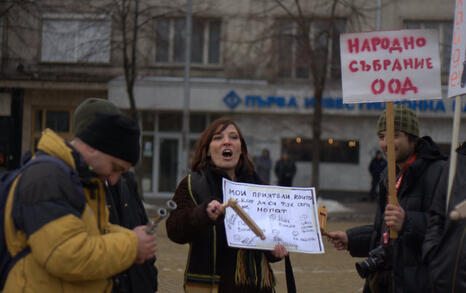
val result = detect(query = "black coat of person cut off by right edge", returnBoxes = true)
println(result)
[423,143,466,293]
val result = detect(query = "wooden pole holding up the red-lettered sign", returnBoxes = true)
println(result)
[385,102,399,239]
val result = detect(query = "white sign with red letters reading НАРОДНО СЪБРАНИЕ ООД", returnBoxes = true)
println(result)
[340,30,441,103]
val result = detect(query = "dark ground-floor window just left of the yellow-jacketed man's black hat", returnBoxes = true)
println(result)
[31,107,73,150]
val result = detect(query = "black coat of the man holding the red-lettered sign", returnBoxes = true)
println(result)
[347,137,446,293]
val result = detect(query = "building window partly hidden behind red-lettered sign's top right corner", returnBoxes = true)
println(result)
[405,21,453,75]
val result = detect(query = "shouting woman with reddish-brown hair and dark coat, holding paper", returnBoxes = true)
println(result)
[166,118,288,293]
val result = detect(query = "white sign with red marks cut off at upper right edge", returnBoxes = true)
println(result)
[448,0,466,98]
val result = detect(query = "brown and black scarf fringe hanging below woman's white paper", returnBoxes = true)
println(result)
[235,249,275,289]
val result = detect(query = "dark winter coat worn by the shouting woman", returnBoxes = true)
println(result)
[166,167,279,293]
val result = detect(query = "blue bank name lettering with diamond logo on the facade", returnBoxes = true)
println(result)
[223,90,466,113]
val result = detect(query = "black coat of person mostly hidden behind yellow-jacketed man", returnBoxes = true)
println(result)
[107,172,157,293]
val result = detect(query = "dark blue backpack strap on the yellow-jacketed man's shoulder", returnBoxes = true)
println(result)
[0,154,84,291]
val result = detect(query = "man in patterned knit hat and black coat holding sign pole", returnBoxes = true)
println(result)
[328,104,446,293]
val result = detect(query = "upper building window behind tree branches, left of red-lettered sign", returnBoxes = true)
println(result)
[277,19,345,79]
